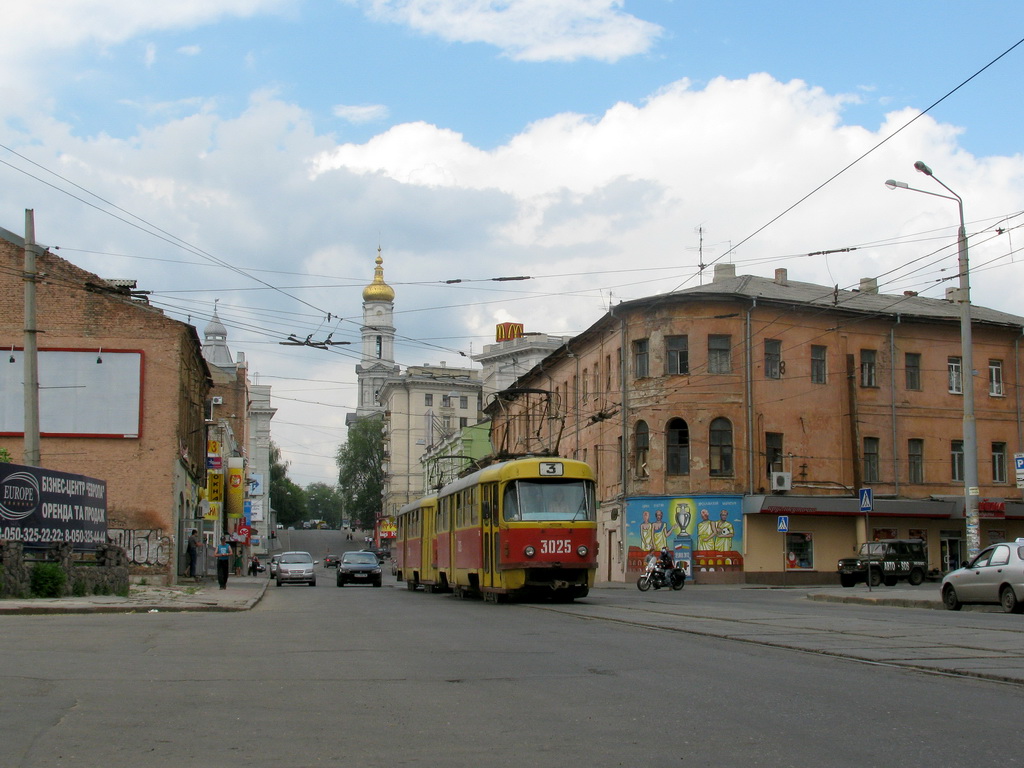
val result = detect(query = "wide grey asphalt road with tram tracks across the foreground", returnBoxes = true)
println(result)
[0,548,1022,768]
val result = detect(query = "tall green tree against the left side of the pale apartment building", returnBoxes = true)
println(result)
[336,417,384,529]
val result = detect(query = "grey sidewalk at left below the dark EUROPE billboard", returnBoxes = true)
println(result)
[0,575,270,615]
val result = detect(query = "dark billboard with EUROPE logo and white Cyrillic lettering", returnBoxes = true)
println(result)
[0,464,106,549]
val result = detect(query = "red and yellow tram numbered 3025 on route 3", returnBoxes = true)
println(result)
[392,457,597,601]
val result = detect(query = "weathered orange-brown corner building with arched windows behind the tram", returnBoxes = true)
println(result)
[488,264,1024,583]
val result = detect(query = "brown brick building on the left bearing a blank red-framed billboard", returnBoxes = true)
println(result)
[0,222,211,575]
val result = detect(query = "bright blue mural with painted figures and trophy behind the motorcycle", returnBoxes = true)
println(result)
[626,496,743,573]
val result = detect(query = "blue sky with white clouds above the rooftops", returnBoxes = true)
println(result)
[0,0,1024,484]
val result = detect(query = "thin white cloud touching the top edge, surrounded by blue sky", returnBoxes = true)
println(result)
[360,0,663,61]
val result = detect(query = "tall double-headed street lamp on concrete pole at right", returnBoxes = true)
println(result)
[886,160,981,559]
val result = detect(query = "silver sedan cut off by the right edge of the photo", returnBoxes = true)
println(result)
[941,539,1024,613]
